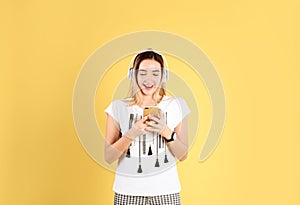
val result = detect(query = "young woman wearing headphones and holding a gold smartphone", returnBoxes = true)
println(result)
[104,49,190,205]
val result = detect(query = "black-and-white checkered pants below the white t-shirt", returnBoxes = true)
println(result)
[114,193,181,205]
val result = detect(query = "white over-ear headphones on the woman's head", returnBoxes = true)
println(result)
[128,48,169,83]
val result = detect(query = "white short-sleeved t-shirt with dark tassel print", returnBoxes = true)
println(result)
[105,96,190,196]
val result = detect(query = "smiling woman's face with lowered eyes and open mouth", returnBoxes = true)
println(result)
[137,59,161,96]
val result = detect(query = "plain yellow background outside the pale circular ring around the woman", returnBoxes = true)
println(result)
[0,0,300,205]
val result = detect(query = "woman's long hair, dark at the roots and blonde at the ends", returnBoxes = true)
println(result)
[129,50,166,105]
